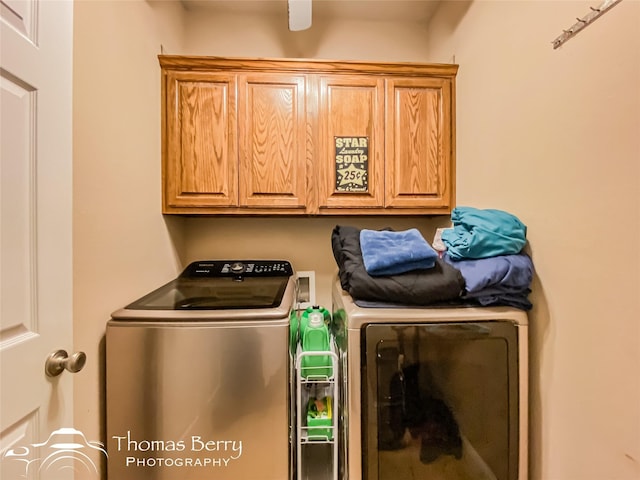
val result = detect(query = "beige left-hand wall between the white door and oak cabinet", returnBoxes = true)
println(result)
[73,1,184,464]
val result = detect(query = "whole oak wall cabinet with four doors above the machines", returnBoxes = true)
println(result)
[159,55,458,215]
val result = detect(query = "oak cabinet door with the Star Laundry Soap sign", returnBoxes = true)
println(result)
[318,75,384,208]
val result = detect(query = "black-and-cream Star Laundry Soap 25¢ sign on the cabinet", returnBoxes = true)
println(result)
[334,137,369,192]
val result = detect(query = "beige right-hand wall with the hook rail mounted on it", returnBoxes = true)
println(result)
[429,0,640,480]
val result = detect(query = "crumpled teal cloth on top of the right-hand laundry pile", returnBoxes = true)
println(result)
[442,207,527,260]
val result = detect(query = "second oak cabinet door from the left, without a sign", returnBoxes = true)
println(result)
[238,73,307,209]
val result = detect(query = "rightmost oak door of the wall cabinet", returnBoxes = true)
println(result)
[385,77,454,208]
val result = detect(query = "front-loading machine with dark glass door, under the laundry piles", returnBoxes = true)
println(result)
[332,281,528,480]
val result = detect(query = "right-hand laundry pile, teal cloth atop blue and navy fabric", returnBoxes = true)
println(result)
[442,207,534,310]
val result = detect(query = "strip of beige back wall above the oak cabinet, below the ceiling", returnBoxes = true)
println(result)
[179,9,428,61]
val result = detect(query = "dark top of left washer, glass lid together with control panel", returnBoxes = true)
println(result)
[125,260,293,310]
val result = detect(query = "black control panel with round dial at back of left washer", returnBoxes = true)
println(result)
[180,260,293,278]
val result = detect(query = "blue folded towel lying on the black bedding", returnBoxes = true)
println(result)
[360,228,438,276]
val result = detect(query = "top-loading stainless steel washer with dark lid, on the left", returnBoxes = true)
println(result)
[106,260,295,480]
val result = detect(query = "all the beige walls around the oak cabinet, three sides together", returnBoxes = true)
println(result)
[74,0,640,480]
